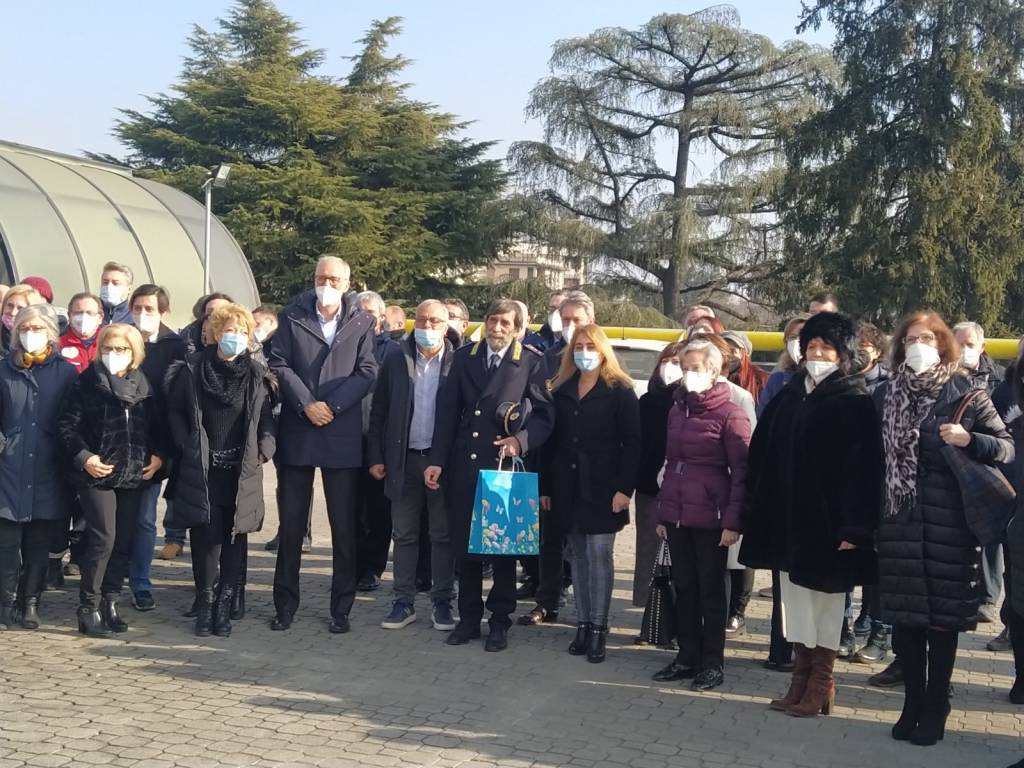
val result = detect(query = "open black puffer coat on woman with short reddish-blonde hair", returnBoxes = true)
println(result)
[167,350,276,534]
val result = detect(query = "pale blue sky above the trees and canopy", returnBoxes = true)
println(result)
[0,0,830,156]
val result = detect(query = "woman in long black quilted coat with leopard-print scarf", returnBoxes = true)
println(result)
[874,312,1014,745]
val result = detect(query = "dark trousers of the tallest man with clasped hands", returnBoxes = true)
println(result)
[273,464,362,618]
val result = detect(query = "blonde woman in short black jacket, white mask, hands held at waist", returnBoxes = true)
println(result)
[57,323,167,636]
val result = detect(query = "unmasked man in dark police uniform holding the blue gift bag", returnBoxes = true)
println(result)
[424,299,555,651]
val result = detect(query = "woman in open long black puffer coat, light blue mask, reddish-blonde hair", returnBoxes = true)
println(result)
[167,304,274,637]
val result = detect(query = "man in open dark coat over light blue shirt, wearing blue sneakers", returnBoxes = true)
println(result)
[368,300,455,631]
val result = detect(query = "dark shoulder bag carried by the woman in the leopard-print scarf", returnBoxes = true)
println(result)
[942,389,1017,547]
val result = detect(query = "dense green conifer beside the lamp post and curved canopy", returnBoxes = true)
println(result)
[104,0,504,300]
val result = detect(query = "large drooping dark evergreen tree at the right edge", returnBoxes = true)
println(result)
[784,0,1024,328]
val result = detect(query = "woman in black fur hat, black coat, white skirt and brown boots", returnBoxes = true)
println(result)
[739,312,882,717]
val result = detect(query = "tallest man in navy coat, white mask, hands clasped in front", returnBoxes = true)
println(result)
[270,255,377,634]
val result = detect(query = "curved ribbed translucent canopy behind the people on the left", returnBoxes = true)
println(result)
[0,141,259,326]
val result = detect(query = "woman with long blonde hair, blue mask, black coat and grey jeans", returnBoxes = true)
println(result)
[541,326,640,663]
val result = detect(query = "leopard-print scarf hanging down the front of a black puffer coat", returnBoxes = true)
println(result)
[882,362,959,517]
